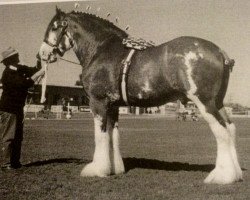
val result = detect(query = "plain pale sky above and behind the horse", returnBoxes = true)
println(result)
[0,0,250,107]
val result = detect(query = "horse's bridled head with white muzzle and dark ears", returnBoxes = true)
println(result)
[39,8,73,62]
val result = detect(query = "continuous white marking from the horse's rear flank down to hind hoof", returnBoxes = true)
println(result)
[184,54,242,184]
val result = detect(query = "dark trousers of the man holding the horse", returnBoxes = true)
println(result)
[0,111,23,166]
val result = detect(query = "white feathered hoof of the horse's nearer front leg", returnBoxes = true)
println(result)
[81,162,111,177]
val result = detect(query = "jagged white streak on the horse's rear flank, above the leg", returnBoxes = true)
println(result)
[184,51,198,94]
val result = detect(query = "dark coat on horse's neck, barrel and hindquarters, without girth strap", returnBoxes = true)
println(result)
[39,10,234,122]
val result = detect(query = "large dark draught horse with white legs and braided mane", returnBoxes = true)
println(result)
[39,8,242,184]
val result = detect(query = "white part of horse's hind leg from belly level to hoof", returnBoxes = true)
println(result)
[188,95,242,184]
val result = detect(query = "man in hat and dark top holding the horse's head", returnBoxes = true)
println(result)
[0,47,44,169]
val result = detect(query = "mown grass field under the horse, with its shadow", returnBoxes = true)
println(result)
[0,116,250,200]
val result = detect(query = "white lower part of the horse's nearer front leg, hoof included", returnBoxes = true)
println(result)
[81,117,111,177]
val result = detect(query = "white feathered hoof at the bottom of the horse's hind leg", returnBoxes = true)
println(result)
[204,168,242,184]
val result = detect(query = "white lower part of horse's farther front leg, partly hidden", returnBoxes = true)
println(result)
[113,124,125,174]
